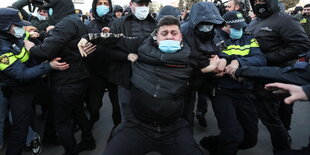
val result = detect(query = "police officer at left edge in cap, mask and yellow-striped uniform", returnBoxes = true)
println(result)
[0,8,69,155]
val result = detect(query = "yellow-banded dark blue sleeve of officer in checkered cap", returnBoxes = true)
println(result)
[237,38,267,66]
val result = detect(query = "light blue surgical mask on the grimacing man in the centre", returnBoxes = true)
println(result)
[158,40,181,53]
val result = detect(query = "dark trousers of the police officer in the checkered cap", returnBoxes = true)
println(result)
[212,88,258,155]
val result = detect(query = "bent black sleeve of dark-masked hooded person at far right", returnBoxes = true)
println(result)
[265,17,310,65]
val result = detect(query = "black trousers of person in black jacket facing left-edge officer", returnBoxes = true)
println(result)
[52,80,91,155]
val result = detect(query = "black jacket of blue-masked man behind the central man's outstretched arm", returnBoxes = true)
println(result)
[85,0,113,78]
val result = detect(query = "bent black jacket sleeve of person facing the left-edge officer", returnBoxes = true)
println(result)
[29,20,77,60]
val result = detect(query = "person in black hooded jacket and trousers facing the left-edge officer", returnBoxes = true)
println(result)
[25,0,93,154]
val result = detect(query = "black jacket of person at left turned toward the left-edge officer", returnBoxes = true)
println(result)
[30,0,88,86]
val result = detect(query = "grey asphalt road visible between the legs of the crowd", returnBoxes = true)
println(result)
[0,95,310,155]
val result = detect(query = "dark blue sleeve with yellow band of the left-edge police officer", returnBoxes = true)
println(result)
[0,53,52,82]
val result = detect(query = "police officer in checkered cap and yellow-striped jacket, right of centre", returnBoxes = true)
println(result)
[201,11,267,155]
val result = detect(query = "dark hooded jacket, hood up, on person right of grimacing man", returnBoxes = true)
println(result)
[181,2,224,89]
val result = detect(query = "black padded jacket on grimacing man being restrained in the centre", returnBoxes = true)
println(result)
[88,34,208,121]
